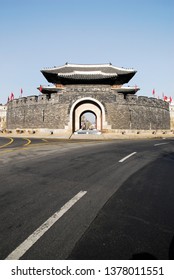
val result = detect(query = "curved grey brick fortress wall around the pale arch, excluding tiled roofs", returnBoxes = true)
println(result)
[7,85,170,132]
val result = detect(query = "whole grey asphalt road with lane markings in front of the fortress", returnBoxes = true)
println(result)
[0,137,174,260]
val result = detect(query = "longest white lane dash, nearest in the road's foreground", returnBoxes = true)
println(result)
[6,191,87,260]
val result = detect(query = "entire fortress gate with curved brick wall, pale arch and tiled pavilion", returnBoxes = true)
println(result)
[7,63,170,135]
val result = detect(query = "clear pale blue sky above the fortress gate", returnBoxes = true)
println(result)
[0,0,174,104]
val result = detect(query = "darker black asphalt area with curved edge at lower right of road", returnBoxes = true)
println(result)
[69,153,174,260]
